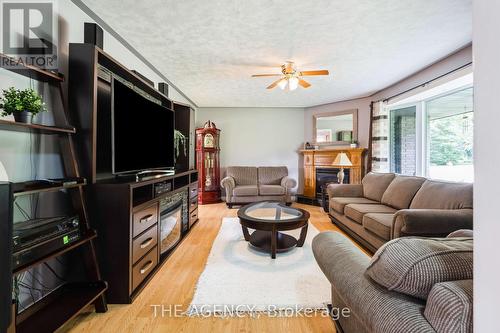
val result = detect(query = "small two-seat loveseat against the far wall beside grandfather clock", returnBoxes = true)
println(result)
[221,166,297,208]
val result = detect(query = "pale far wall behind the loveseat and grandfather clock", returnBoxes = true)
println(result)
[196,108,304,193]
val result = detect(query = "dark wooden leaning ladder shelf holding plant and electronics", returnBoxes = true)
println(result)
[0,48,107,333]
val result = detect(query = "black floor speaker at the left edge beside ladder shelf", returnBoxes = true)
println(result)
[0,182,12,332]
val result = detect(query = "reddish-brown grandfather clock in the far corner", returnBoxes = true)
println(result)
[196,120,220,205]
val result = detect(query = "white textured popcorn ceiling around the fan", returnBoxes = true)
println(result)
[83,0,472,107]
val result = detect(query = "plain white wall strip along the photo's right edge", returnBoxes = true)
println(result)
[473,1,500,333]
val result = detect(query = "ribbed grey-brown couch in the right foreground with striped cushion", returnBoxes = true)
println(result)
[312,230,473,333]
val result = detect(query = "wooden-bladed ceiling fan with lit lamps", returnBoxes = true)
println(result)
[252,61,330,90]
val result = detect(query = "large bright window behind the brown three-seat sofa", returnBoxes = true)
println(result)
[389,85,474,182]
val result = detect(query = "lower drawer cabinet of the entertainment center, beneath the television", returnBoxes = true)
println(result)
[88,170,198,303]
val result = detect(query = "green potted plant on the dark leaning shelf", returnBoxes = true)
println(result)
[0,87,47,124]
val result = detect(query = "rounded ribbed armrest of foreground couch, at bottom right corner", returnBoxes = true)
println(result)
[424,280,473,333]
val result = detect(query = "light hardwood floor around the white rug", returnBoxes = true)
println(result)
[60,203,360,333]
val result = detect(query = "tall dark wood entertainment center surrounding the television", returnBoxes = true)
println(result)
[69,43,198,303]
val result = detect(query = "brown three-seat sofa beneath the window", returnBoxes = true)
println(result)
[327,173,472,252]
